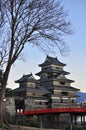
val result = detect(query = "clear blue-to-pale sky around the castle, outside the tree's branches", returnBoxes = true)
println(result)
[8,0,86,92]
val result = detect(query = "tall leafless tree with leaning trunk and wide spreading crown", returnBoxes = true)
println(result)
[0,0,72,128]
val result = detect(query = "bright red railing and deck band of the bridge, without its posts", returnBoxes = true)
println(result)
[19,107,86,115]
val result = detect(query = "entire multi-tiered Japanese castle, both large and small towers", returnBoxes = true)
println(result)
[13,56,80,110]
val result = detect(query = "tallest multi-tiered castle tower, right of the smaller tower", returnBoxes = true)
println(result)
[36,56,79,108]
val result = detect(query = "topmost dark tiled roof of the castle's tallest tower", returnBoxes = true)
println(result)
[39,55,66,67]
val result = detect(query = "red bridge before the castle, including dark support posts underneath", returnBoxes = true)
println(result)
[19,107,86,129]
